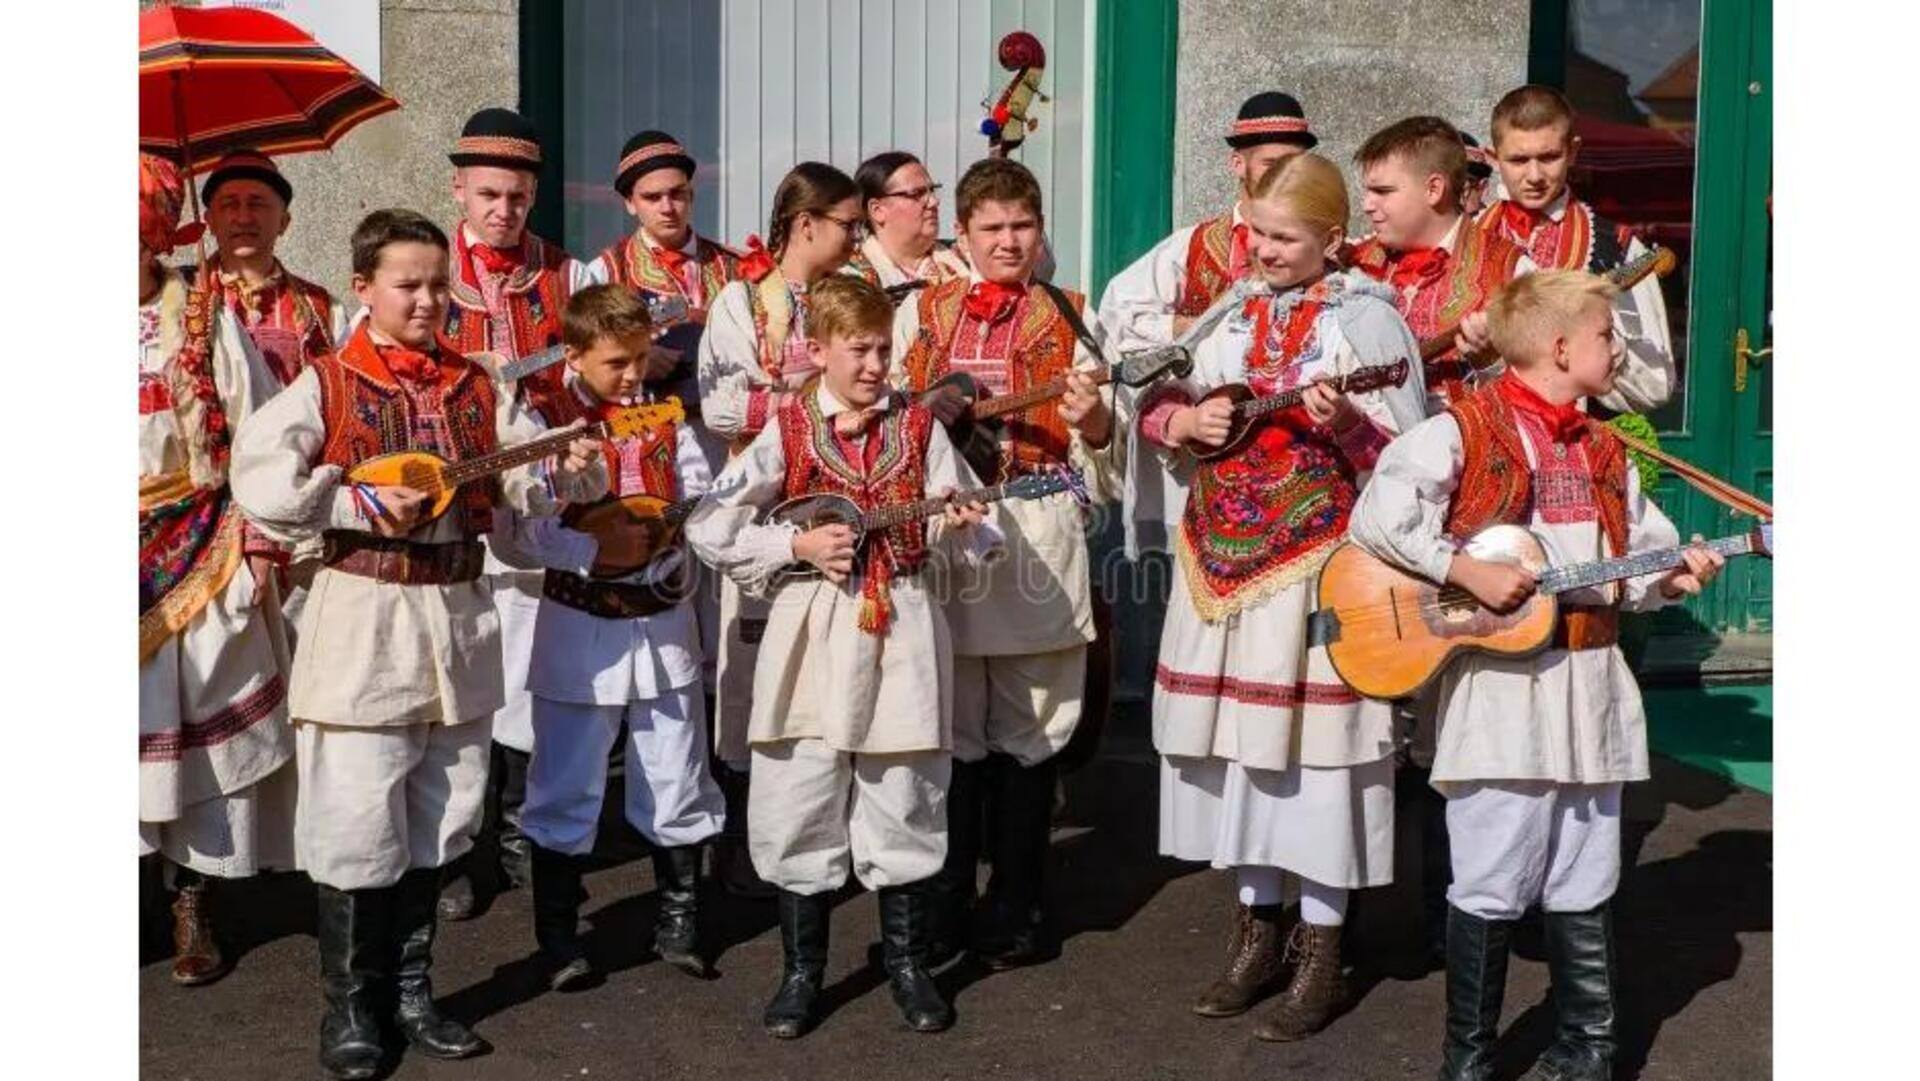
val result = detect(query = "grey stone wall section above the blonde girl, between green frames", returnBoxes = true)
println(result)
[1173,0,1530,223]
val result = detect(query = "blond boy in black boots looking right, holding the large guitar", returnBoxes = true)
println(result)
[1352,271,1724,1081]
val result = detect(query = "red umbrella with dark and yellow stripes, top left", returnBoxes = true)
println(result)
[140,4,399,173]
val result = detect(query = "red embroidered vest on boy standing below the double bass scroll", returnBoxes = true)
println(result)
[900,278,1087,482]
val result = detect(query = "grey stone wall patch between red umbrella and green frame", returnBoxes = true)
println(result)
[140,0,520,299]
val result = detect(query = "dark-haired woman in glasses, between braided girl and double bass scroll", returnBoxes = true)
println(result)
[847,150,966,293]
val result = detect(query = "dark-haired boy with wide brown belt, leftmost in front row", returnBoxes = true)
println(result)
[232,209,607,1077]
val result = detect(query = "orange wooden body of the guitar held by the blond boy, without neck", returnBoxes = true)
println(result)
[1319,526,1559,699]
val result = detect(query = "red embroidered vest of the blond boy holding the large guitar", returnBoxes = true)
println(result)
[1446,386,1628,555]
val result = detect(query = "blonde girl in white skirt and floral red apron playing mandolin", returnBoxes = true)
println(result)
[1127,154,1423,1041]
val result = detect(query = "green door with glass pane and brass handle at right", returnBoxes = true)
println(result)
[1532,0,1772,636]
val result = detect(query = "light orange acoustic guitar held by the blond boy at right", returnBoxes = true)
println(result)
[1309,522,1774,699]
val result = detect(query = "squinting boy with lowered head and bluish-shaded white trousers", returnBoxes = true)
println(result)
[495,286,726,989]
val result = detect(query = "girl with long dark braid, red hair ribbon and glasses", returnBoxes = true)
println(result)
[699,161,866,897]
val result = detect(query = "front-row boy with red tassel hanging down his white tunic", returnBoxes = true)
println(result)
[687,275,993,1039]
